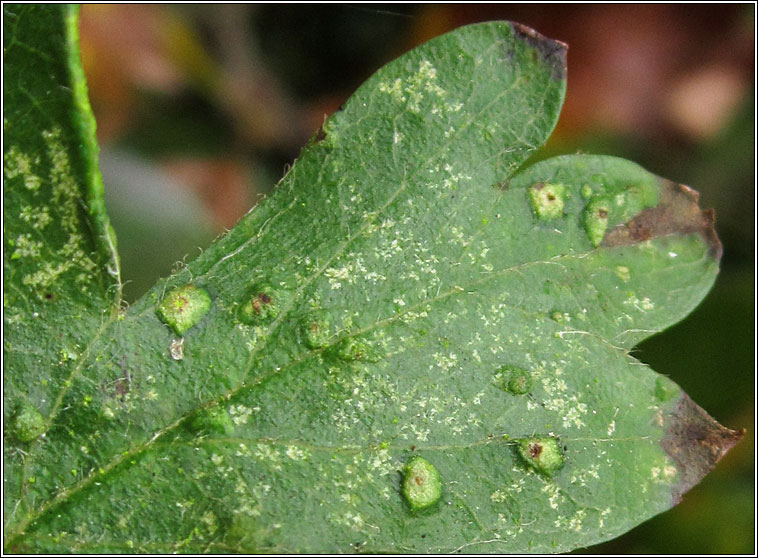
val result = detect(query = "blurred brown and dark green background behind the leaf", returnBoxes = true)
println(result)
[81,3,755,554]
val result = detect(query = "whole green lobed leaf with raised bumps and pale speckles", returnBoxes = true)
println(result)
[4,5,739,553]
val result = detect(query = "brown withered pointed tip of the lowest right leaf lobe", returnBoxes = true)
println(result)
[661,394,745,505]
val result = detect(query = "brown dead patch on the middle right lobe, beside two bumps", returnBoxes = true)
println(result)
[602,179,722,261]
